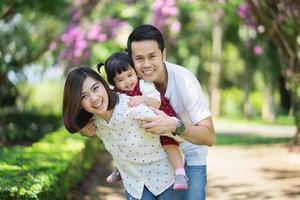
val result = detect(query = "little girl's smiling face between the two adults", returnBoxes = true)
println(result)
[113,67,138,91]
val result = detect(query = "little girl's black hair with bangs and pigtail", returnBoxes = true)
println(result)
[97,52,133,86]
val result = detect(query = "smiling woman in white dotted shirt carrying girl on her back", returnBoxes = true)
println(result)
[63,67,184,200]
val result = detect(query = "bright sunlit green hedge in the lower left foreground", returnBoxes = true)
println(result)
[0,129,101,200]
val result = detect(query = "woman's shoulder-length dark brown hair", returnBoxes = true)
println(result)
[63,67,119,133]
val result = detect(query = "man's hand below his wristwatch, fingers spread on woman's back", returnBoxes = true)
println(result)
[137,107,178,135]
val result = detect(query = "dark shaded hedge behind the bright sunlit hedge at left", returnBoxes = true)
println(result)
[0,113,61,143]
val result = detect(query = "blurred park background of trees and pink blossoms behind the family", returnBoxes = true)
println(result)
[0,0,300,199]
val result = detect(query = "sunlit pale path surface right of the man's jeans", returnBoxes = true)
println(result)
[207,146,300,200]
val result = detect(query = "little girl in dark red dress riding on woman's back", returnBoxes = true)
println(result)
[97,52,188,190]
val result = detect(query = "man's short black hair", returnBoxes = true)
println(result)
[127,24,165,55]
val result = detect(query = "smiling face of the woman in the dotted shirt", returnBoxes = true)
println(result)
[81,77,109,116]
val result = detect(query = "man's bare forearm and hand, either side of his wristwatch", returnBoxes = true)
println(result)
[140,108,216,146]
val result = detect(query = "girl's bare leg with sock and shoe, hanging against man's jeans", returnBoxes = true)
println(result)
[163,144,188,190]
